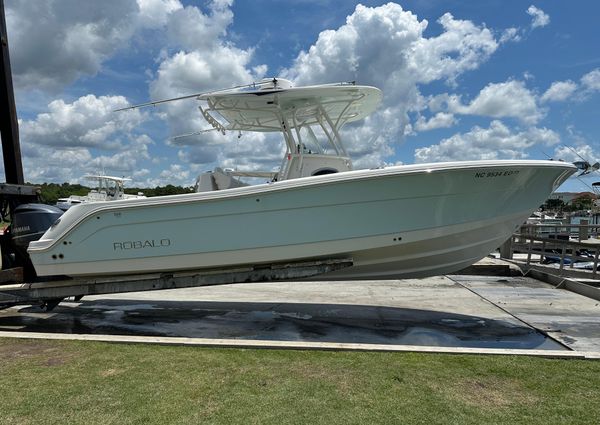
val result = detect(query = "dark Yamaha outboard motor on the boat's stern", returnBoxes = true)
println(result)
[10,204,64,279]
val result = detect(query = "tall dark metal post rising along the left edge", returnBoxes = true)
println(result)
[0,0,25,184]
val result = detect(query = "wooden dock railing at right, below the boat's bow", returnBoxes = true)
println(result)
[500,224,600,279]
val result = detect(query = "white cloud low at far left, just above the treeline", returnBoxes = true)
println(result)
[19,95,153,182]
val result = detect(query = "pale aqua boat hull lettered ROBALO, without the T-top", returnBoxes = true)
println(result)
[28,161,575,280]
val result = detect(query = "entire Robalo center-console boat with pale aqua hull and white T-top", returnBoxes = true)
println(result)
[28,80,576,280]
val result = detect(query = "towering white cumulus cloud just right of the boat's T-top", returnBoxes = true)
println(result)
[282,3,498,167]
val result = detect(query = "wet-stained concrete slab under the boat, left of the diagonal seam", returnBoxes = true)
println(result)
[0,276,565,350]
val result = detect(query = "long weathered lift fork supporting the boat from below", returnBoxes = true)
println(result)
[0,258,353,311]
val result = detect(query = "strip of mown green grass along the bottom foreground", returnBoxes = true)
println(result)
[0,338,600,424]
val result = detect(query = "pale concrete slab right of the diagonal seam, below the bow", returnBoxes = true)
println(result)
[452,276,600,351]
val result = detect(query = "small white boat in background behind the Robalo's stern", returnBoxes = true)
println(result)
[56,175,145,211]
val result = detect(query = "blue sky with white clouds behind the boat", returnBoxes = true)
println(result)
[5,0,600,191]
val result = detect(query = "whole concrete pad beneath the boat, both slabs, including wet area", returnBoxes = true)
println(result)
[0,260,600,358]
